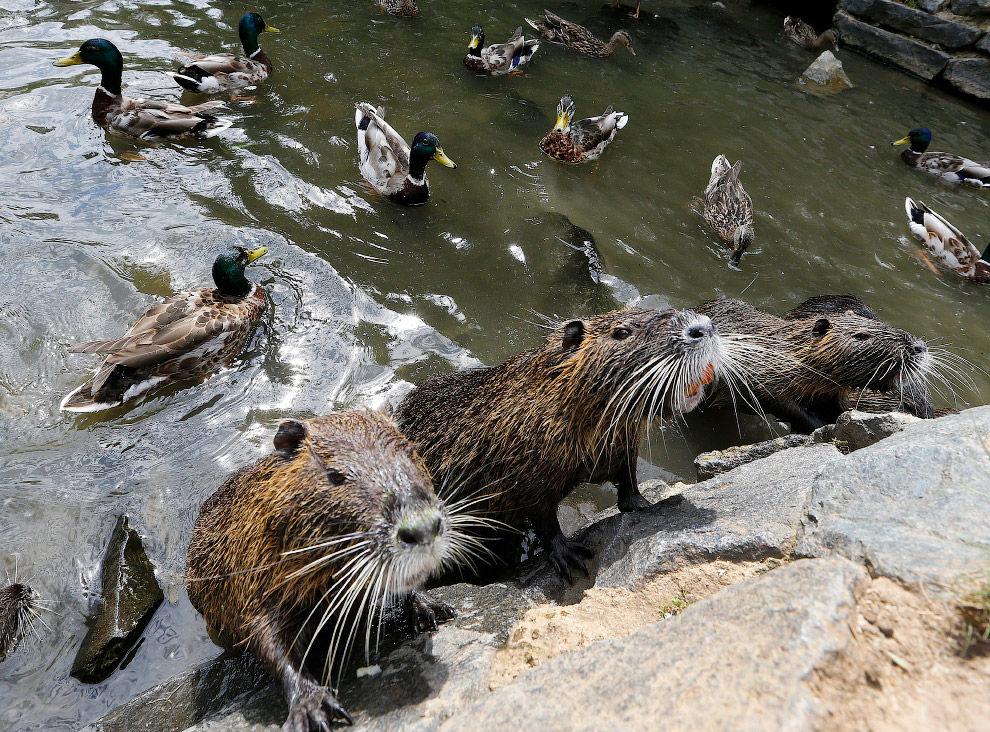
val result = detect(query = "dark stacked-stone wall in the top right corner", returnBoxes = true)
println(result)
[834,0,990,101]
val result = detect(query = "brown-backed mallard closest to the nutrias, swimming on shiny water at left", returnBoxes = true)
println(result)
[61,247,268,412]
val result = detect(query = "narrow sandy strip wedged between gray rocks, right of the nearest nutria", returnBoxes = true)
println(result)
[489,559,781,691]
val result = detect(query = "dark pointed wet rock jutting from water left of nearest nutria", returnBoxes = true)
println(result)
[72,516,165,684]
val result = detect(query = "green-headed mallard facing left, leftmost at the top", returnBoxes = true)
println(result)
[54,38,231,140]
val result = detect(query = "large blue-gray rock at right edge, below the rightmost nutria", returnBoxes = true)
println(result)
[795,407,990,591]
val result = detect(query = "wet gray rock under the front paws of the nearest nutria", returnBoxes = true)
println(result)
[84,584,533,732]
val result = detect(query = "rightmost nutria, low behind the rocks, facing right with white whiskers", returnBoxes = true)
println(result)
[695,295,931,433]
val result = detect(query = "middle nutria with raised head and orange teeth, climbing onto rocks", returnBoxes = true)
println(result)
[396,309,728,580]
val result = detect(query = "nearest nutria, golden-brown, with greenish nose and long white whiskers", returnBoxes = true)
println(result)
[186,411,482,732]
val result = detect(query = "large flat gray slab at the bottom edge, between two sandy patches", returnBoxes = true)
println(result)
[440,556,866,732]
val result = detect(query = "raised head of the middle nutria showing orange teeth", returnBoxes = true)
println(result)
[545,308,725,421]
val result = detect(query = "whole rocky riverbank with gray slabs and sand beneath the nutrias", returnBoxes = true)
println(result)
[87,407,990,732]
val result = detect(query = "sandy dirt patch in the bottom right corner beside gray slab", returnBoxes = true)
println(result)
[811,578,990,732]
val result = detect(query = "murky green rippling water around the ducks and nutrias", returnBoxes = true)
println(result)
[0,0,990,730]
